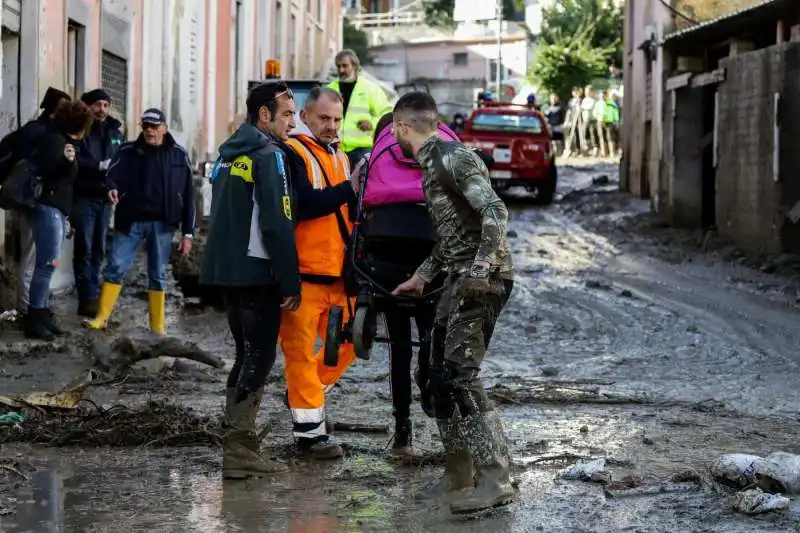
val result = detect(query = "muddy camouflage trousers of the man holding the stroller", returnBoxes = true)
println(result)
[429,275,514,419]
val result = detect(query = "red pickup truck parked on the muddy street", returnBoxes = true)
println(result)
[461,102,558,205]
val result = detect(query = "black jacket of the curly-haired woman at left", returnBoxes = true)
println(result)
[27,126,78,216]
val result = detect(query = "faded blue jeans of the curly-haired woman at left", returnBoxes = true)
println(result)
[28,205,67,309]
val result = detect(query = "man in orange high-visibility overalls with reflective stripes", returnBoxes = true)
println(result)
[280,87,357,459]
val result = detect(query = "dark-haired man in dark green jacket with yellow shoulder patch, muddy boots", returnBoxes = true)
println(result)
[200,82,300,479]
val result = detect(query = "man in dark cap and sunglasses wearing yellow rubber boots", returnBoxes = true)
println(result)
[87,109,195,335]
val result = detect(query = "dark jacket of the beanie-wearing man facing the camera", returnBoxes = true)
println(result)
[75,117,124,200]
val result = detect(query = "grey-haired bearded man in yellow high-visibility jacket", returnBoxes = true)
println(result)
[328,48,392,167]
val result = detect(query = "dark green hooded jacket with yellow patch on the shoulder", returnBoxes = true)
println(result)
[200,124,300,297]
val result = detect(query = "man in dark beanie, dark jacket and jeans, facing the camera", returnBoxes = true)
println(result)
[71,89,124,318]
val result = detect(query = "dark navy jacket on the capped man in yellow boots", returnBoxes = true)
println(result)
[105,133,195,235]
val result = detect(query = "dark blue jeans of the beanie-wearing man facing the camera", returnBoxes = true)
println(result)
[70,198,111,301]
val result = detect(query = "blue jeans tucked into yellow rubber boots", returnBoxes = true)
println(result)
[103,222,173,291]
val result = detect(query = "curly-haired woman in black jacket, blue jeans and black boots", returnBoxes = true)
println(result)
[24,101,93,340]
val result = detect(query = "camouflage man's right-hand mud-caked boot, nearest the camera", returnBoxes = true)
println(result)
[450,411,515,514]
